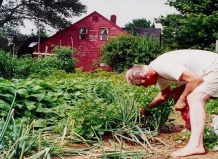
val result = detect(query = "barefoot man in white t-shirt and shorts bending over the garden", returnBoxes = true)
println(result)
[126,50,218,157]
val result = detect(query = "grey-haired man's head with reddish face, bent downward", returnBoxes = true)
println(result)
[126,65,158,87]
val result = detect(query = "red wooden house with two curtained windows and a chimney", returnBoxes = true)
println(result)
[34,11,124,71]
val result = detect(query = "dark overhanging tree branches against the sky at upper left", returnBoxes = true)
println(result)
[0,0,86,29]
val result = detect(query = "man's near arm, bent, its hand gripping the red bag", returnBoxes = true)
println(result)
[176,70,204,110]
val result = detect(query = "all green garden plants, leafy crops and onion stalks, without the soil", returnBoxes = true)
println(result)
[0,71,172,157]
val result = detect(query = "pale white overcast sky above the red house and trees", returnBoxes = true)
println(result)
[21,0,176,34]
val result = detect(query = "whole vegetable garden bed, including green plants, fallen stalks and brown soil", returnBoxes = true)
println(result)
[0,71,218,159]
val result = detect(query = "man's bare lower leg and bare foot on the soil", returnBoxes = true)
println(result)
[171,92,210,157]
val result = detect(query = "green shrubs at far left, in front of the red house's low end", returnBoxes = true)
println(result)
[0,47,76,79]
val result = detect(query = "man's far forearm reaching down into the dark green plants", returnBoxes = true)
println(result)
[149,86,172,108]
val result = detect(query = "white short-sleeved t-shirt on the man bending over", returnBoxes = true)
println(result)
[149,50,218,90]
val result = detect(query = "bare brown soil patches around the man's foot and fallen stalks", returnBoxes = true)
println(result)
[54,112,218,159]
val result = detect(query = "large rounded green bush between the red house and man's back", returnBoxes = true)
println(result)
[101,34,167,72]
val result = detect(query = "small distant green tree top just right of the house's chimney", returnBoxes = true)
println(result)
[125,18,155,32]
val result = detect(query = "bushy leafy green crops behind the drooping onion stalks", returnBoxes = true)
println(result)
[0,72,171,138]
